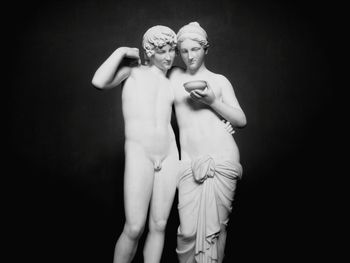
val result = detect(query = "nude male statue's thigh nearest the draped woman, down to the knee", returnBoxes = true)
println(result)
[150,152,179,224]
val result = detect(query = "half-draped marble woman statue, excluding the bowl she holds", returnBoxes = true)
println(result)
[170,22,246,263]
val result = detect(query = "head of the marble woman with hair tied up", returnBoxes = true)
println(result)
[177,22,209,72]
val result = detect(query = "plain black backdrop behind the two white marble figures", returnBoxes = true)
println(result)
[8,0,332,263]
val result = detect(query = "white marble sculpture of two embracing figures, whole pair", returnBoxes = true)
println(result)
[92,22,246,263]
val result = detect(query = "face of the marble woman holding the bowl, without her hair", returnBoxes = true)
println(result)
[180,38,207,71]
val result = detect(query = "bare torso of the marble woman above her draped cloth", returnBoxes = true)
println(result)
[171,69,239,162]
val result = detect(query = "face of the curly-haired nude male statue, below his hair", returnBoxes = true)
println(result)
[150,44,175,71]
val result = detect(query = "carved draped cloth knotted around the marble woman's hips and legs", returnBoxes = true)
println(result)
[176,155,242,263]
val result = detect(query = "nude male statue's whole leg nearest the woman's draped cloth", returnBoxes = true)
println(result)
[143,154,179,263]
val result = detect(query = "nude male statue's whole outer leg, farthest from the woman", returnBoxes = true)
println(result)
[114,144,153,263]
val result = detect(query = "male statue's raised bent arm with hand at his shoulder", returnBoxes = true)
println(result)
[92,47,141,89]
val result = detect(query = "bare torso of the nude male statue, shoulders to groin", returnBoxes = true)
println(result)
[122,67,177,169]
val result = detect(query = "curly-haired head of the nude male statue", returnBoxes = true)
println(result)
[142,25,177,71]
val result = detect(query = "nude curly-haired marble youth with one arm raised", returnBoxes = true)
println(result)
[92,26,179,263]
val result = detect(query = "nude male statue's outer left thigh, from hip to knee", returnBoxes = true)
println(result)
[124,144,154,226]
